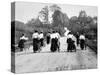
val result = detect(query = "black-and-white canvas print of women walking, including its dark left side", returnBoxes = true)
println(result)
[11,1,98,73]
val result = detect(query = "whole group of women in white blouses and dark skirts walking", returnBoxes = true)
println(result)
[18,28,85,53]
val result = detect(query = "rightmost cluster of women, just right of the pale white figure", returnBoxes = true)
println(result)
[67,32,86,52]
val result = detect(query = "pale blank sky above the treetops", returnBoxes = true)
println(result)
[15,2,98,23]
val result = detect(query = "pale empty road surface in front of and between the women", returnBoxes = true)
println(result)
[12,37,97,73]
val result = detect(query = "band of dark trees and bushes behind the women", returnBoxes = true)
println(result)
[11,5,97,46]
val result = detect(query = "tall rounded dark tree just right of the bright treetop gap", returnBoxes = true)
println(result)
[50,5,69,27]
